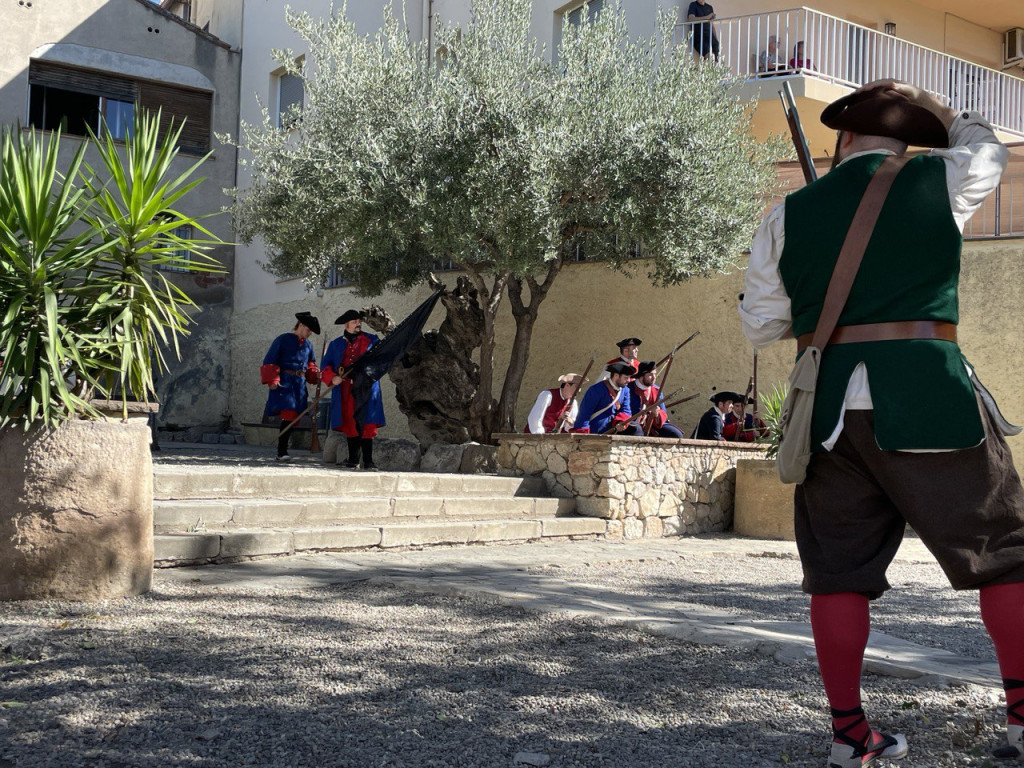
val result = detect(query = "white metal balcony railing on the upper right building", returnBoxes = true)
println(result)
[676,8,1024,136]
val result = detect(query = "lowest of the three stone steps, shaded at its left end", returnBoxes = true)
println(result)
[154,517,607,567]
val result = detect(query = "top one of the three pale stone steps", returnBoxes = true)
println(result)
[153,464,548,499]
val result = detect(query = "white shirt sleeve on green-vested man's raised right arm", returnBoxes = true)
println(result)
[931,112,1010,232]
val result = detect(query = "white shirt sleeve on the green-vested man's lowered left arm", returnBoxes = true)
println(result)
[739,203,793,349]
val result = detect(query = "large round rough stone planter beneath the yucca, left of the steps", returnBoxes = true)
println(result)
[0,403,157,600]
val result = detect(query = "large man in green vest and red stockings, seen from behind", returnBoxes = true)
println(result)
[739,80,1024,768]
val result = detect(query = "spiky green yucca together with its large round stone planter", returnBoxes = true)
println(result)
[0,112,219,600]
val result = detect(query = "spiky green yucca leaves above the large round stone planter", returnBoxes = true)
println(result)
[0,114,219,428]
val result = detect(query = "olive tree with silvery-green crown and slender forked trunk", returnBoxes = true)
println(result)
[237,0,777,440]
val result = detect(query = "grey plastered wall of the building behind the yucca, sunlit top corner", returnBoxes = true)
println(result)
[0,0,241,428]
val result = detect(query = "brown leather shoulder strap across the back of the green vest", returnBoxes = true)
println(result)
[811,155,909,349]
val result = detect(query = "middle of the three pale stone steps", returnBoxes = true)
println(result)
[153,496,575,534]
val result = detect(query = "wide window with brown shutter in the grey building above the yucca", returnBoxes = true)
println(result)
[29,60,213,153]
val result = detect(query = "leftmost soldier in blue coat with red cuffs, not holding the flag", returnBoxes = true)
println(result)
[260,312,319,461]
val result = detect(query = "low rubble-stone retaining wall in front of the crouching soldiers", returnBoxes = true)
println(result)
[495,434,764,539]
